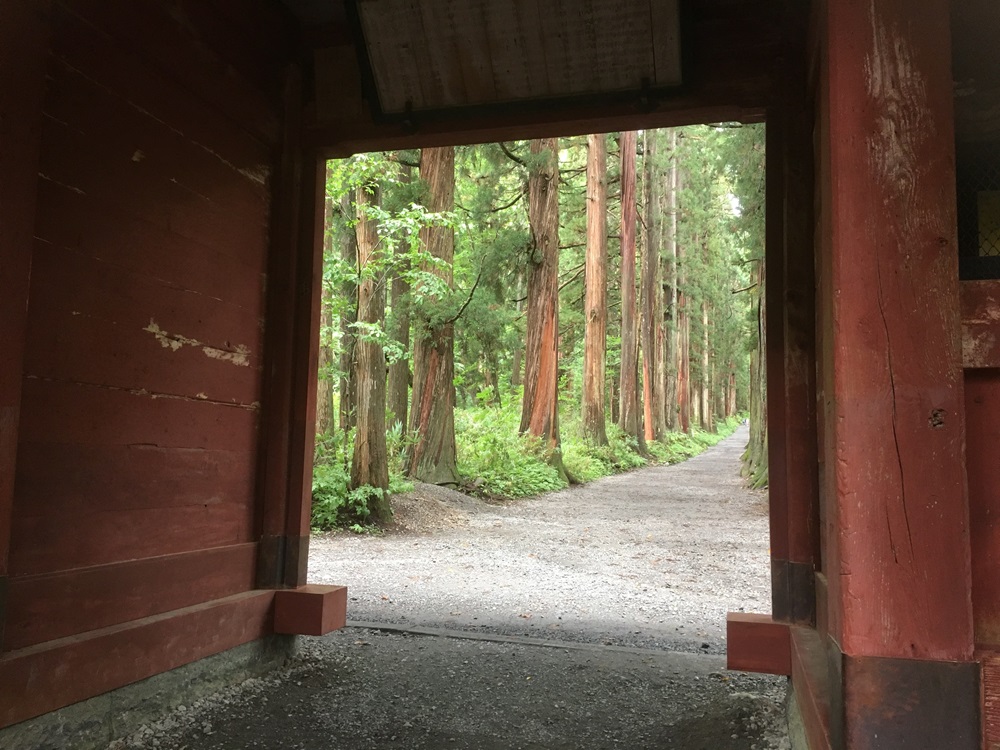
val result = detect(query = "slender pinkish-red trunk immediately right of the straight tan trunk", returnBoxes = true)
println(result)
[618,130,646,452]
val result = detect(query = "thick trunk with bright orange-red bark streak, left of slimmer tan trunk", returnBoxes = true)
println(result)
[521,138,565,475]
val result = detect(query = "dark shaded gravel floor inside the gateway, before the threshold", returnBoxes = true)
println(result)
[112,628,788,750]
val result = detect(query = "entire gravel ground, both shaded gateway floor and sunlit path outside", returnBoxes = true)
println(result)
[113,430,788,750]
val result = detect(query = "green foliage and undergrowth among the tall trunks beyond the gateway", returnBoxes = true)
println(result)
[313,124,766,530]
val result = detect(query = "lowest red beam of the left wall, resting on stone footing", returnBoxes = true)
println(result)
[0,591,274,727]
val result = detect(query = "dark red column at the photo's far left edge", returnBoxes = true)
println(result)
[0,0,49,648]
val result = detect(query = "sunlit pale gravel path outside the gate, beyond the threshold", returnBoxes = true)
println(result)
[309,427,770,653]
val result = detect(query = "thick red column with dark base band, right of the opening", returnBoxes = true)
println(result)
[821,0,979,750]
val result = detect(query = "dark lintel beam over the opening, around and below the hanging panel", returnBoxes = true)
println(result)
[306,2,785,158]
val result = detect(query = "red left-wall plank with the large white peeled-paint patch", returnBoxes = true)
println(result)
[24,243,261,405]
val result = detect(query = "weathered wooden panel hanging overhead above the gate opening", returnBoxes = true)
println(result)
[355,0,681,114]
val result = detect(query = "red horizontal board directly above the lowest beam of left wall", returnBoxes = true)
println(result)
[2,543,257,651]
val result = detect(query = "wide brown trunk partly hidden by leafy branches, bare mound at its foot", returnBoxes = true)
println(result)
[406,146,458,484]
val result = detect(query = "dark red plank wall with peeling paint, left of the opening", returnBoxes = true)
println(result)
[0,0,290,720]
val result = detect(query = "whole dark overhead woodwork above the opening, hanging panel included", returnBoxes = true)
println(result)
[278,0,792,156]
